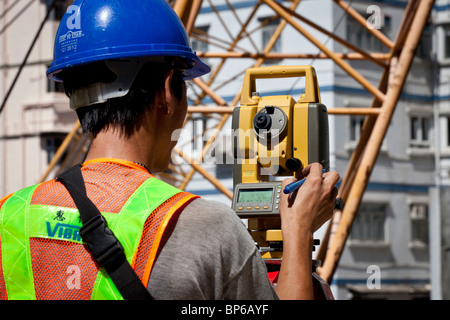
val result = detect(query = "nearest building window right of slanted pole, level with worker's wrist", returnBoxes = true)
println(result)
[350,203,386,242]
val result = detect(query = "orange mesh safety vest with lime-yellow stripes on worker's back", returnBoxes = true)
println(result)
[0,160,198,300]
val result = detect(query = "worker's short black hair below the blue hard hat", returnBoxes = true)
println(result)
[63,62,183,138]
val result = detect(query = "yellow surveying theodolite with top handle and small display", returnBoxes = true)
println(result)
[232,66,331,296]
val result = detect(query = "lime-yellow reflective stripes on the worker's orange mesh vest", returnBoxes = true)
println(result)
[0,177,197,300]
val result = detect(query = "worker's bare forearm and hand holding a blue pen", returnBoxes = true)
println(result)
[276,163,339,299]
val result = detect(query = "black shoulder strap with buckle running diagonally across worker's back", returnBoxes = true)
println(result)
[56,165,152,300]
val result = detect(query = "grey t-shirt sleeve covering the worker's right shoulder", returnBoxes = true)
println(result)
[148,199,278,300]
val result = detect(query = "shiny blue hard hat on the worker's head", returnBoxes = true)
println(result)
[47,0,211,81]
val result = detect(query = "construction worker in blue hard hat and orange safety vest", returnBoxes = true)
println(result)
[0,0,339,299]
